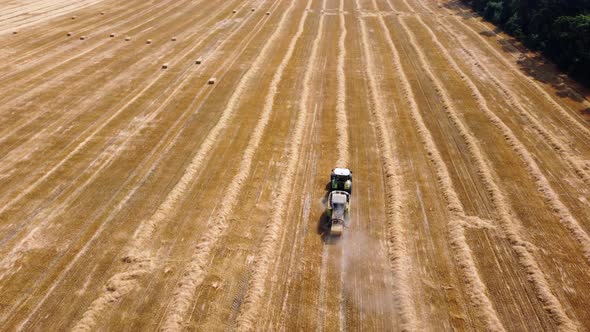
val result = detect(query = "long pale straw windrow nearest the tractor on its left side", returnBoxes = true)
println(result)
[237,0,326,331]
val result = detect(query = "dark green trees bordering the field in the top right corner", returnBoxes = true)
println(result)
[463,0,590,85]
